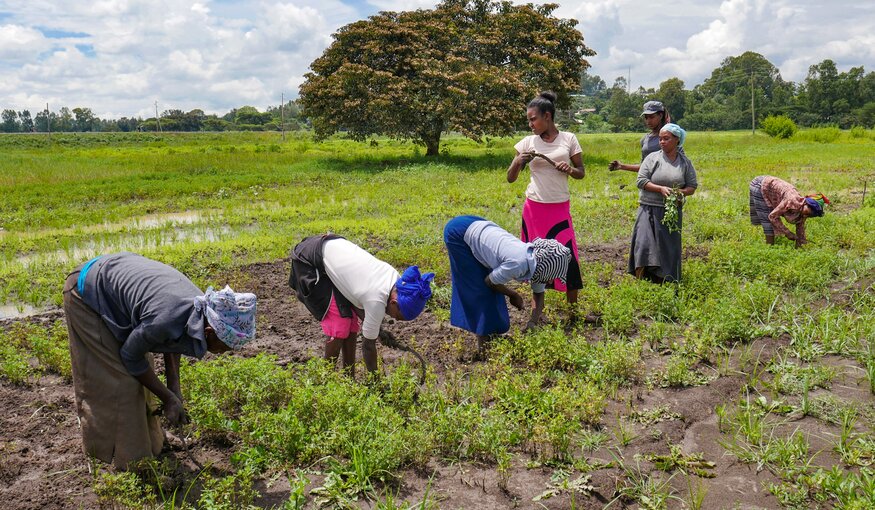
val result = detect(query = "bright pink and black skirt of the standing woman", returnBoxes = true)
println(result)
[520,198,583,292]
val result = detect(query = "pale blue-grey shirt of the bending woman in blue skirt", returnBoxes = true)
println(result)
[464,220,545,292]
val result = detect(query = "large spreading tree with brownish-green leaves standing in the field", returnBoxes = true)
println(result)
[300,0,595,155]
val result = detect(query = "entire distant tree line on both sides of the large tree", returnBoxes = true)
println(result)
[0,51,875,133]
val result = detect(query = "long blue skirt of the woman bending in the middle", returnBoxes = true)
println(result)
[444,216,510,336]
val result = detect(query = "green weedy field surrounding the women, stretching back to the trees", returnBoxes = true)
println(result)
[0,128,875,508]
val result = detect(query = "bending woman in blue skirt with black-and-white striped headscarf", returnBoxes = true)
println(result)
[444,216,571,354]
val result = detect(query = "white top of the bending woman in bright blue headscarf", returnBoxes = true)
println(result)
[322,239,399,340]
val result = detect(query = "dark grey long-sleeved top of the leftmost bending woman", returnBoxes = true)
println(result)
[82,252,207,376]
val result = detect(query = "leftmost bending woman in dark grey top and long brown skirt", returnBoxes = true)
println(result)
[64,252,256,468]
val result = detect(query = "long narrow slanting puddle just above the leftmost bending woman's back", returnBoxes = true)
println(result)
[10,226,231,267]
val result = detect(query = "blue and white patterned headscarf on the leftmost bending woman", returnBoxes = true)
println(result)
[194,285,256,349]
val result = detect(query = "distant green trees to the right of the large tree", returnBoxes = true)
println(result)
[576,51,875,132]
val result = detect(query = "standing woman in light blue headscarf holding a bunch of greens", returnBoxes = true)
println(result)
[629,124,699,283]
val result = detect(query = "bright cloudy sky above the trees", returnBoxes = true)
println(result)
[0,0,875,119]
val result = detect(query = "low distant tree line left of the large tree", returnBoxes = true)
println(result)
[0,101,309,133]
